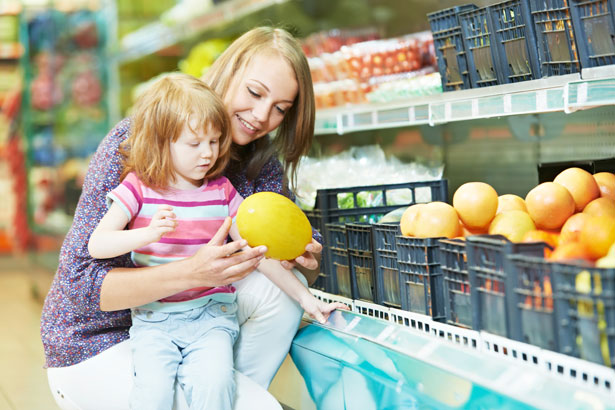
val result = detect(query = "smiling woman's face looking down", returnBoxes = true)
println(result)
[227,54,299,145]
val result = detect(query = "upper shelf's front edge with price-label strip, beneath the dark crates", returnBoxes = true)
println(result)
[315,71,615,135]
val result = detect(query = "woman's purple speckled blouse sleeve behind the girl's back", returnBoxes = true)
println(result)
[58,120,132,313]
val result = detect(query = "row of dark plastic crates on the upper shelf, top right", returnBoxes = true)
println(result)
[427,0,615,86]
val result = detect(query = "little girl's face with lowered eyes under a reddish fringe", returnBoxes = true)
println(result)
[170,120,221,190]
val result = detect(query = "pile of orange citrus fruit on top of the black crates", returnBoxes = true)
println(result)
[400,168,615,267]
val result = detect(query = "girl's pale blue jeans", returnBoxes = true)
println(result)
[130,301,239,410]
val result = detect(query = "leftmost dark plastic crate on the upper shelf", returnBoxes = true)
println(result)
[427,4,477,91]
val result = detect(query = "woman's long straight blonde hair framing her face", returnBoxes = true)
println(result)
[203,27,315,192]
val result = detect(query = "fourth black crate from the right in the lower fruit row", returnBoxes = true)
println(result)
[438,239,472,328]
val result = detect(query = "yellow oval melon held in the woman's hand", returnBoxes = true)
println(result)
[236,192,312,260]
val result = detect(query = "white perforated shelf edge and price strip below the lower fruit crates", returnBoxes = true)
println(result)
[304,289,615,408]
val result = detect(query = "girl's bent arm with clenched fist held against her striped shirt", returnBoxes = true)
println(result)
[88,202,176,259]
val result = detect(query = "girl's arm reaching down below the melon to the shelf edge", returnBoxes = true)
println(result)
[230,224,348,323]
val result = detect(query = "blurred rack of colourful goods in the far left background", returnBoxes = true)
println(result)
[23,8,111,234]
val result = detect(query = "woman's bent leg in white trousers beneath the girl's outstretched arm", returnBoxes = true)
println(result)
[234,269,307,389]
